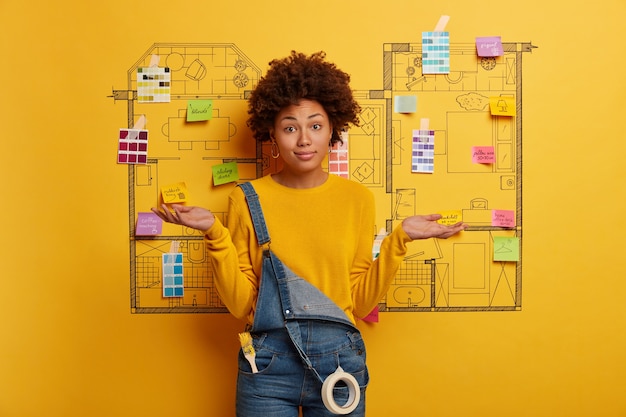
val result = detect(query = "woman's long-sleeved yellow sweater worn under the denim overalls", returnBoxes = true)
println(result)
[205,175,411,323]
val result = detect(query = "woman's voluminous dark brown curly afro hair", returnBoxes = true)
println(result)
[247,51,361,144]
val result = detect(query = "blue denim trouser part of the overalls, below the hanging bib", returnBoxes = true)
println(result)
[237,320,369,417]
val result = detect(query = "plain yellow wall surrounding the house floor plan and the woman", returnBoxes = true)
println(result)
[0,0,626,417]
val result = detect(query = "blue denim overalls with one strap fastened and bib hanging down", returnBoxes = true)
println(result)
[237,183,369,417]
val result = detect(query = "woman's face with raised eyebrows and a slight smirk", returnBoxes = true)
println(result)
[270,99,332,179]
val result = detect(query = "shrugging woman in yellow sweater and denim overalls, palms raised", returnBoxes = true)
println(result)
[153,52,465,417]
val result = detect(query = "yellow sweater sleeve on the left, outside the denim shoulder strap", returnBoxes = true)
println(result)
[205,192,258,323]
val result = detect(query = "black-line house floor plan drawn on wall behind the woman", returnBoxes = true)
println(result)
[112,42,534,313]
